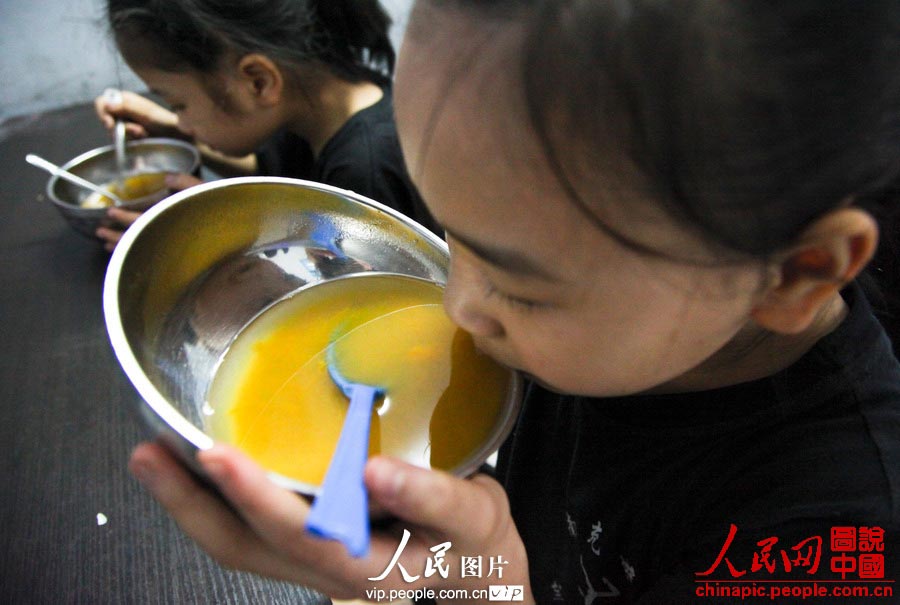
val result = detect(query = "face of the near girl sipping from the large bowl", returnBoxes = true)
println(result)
[395,8,760,396]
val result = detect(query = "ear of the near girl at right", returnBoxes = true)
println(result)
[751,207,878,334]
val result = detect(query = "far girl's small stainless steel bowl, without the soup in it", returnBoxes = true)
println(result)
[47,138,200,238]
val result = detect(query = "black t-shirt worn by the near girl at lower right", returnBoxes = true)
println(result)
[497,286,900,604]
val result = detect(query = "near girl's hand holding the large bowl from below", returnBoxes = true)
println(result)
[130,443,533,603]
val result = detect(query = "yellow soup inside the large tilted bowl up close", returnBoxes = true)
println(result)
[207,274,512,486]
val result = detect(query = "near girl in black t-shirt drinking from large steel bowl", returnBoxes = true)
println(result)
[131,0,900,604]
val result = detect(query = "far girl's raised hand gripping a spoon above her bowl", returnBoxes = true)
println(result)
[94,90,190,139]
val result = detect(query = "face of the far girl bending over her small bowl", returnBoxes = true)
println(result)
[133,66,280,157]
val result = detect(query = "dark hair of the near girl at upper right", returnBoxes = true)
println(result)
[446,0,900,350]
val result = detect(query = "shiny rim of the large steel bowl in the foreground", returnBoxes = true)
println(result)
[103,176,524,495]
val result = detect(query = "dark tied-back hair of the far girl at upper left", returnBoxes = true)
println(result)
[107,0,395,84]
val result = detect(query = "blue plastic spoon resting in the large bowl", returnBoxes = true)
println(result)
[306,341,384,557]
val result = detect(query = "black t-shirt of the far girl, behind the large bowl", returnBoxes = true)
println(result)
[257,87,443,235]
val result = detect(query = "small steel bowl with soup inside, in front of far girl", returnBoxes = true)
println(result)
[47,138,200,238]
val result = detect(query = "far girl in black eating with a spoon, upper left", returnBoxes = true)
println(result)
[95,0,434,249]
